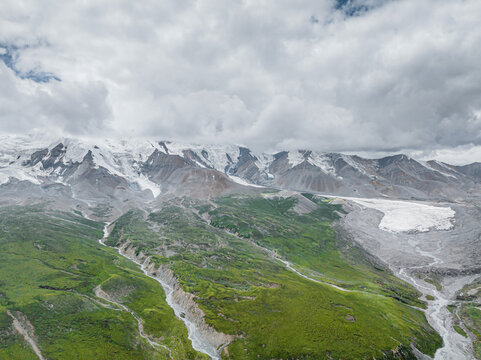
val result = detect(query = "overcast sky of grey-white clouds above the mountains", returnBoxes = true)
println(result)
[0,0,481,163]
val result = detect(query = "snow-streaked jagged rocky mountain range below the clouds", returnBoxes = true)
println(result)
[0,136,481,210]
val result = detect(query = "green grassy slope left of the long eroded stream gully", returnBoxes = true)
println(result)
[0,207,205,360]
